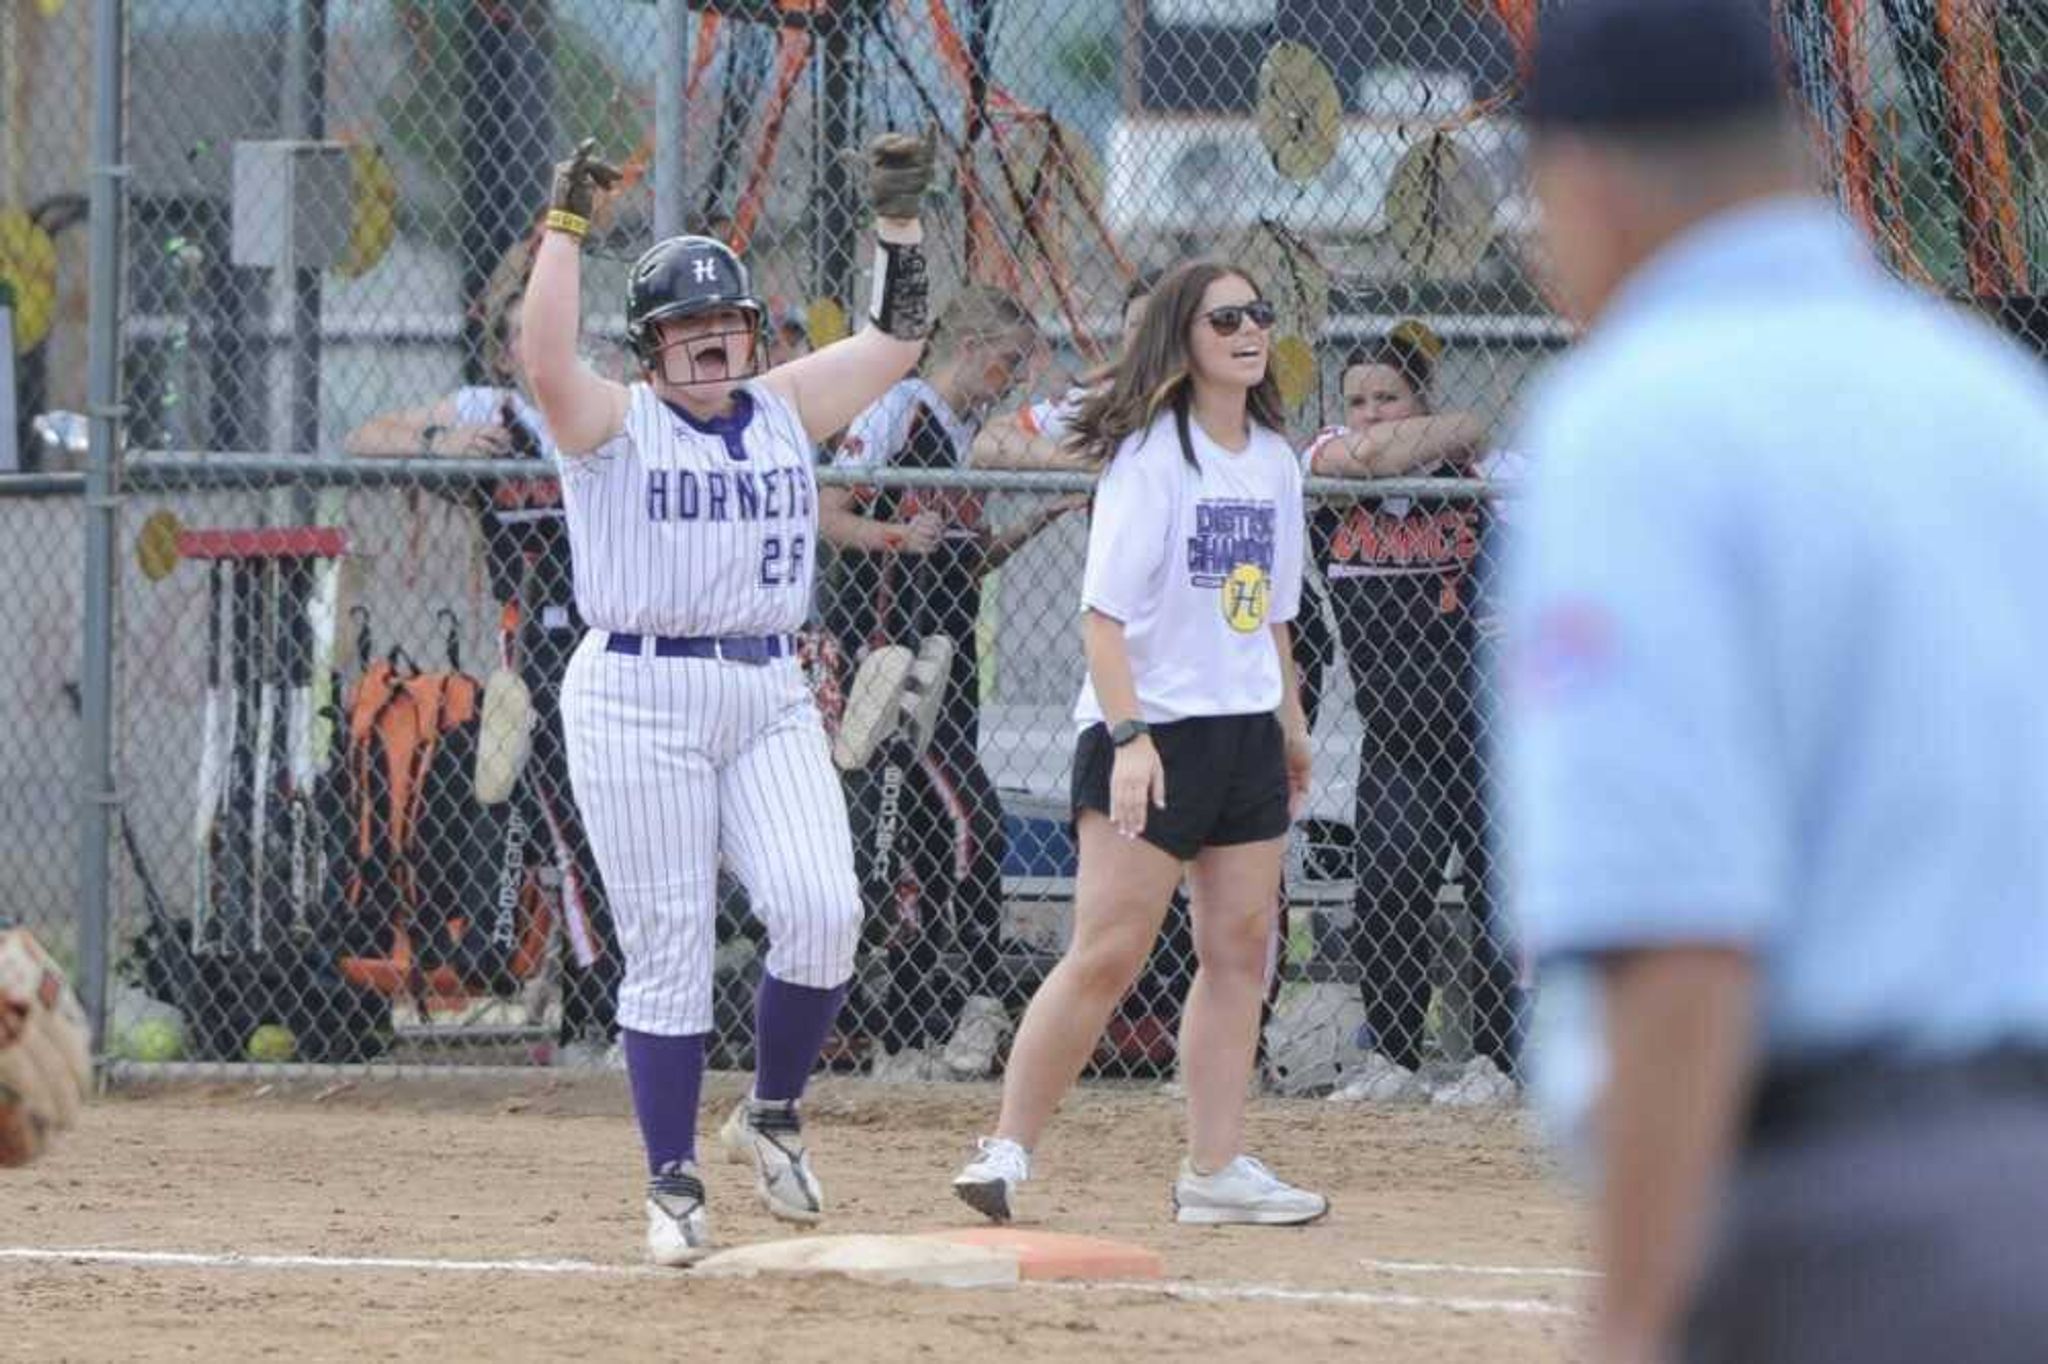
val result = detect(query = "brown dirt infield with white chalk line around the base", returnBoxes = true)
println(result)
[0,1073,1585,1364]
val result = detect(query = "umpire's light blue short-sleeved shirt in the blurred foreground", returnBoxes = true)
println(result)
[1503,199,2048,1069]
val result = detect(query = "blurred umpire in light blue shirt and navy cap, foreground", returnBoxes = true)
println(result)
[1505,0,2048,1364]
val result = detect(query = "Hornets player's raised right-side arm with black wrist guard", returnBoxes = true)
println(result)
[764,129,936,440]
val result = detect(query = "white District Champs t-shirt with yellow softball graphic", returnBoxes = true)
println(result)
[1073,412,1305,729]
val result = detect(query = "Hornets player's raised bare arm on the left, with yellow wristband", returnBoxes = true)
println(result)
[520,137,627,455]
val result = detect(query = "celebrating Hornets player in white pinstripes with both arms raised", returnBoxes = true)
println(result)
[522,133,932,1264]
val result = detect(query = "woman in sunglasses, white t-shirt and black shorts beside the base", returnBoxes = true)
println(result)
[952,260,1329,1225]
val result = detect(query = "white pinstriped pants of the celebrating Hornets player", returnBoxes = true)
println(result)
[561,631,860,1036]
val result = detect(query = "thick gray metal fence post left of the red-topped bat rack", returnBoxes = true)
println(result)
[78,0,127,1055]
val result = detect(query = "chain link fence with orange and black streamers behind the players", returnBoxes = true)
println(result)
[0,0,2048,1081]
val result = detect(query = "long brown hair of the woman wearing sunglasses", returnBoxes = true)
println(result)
[1067,260,1286,465]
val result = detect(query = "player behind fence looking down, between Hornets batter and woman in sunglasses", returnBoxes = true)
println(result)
[819,287,1075,1079]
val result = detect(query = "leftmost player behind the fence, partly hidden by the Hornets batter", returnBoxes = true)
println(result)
[342,248,618,1063]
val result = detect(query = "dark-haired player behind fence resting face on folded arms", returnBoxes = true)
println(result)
[1303,322,1520,1104]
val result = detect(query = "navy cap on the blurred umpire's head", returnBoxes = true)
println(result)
[1522,0,1786,131]
